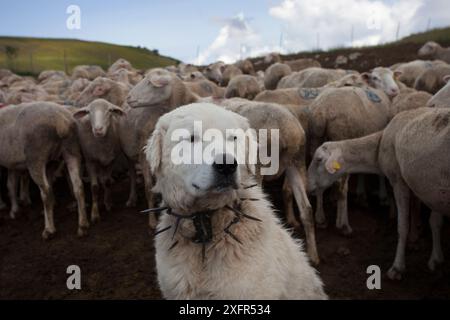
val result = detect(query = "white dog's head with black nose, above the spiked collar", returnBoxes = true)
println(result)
[146,103,256,212]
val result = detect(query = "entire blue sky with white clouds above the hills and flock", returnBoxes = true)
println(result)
[0,0,450,64]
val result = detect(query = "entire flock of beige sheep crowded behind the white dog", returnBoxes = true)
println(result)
[0,42,450,279]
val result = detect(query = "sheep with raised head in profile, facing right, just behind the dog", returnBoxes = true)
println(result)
[119,69,199,229]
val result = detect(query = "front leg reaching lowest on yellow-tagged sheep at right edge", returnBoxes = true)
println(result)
[388,181,410,280]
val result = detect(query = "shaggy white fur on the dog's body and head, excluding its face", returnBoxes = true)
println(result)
[146,103,327,299]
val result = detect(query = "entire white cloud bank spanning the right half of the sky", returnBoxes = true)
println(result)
[191,0,450,64]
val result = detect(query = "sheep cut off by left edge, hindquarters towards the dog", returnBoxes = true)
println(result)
[0,102,89,239]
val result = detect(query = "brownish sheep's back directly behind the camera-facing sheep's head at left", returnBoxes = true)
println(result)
[75,77,130,107]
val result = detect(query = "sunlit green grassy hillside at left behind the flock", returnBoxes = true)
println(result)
[0,37,178,74]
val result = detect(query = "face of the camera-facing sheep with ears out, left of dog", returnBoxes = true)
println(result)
[73,99,125,138]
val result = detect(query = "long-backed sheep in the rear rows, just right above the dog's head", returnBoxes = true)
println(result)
[277,67,348,89]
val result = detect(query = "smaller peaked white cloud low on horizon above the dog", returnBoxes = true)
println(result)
[192,12,281,64]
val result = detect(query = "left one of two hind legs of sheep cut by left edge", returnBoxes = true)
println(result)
[28,161,56,240]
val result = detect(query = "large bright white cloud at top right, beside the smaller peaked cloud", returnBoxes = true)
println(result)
[269,0,425,51]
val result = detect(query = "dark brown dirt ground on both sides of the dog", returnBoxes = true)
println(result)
[0,172,450,299]
